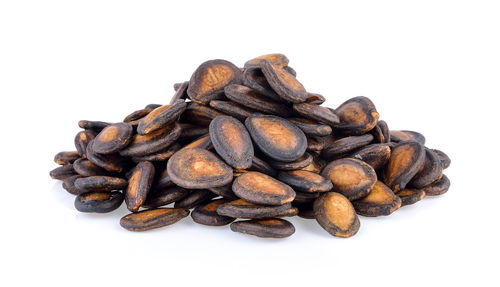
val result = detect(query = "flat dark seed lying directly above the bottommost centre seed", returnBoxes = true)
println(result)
[217,199,292,218]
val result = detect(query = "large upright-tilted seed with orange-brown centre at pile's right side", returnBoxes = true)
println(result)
[384,142,425,192]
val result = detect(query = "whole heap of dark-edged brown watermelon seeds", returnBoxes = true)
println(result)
[50,54,450,238]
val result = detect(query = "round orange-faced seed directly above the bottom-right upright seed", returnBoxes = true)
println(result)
[321,158,377,200]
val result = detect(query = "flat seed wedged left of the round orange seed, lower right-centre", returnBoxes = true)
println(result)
[278,170,333,192]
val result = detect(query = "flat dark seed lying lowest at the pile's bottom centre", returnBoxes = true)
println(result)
[230,218,295,238]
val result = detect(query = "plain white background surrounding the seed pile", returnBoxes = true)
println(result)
[0,0,500,286]
